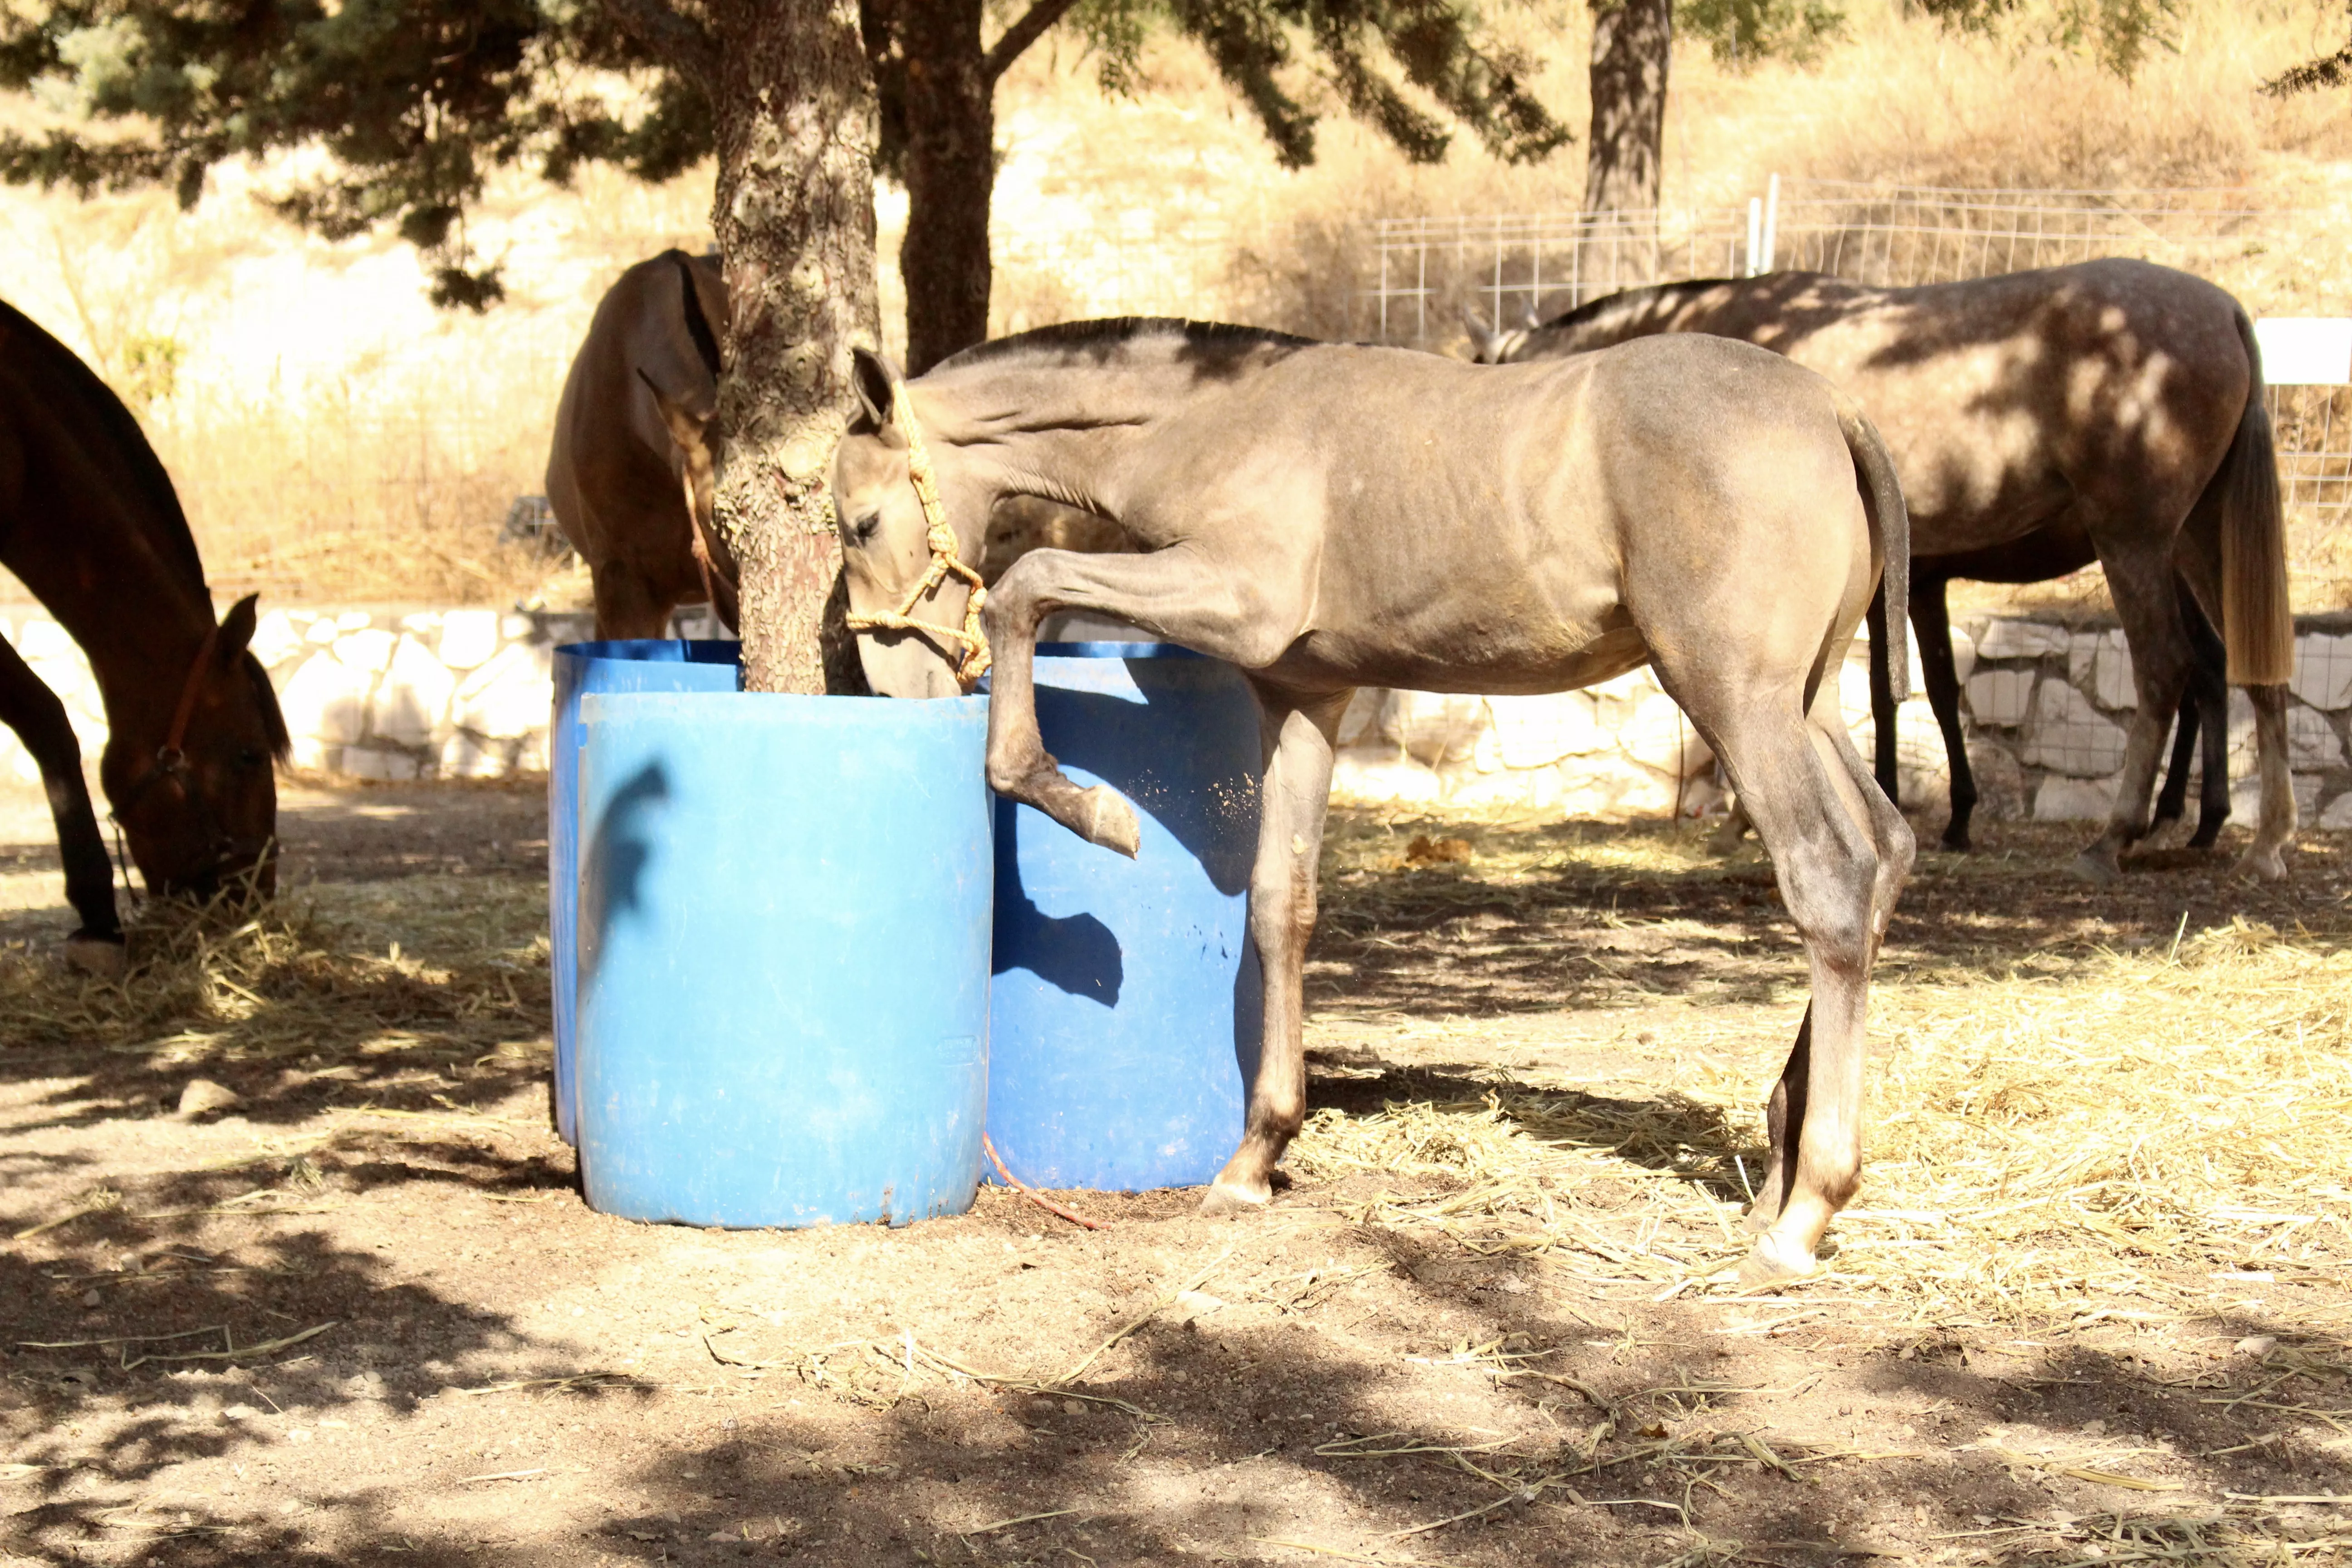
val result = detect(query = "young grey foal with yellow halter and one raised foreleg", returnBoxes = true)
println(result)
[833,320,1912,1279]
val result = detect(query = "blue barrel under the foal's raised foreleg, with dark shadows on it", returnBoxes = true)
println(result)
[988,642,1261,1192]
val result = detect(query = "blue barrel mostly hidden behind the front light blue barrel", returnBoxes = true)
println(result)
[548,637,743,1142]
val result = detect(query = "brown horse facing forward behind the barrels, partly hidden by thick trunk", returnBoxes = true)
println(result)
[548,249,736,637]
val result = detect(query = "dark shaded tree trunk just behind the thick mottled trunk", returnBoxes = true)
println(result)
[898,0,997,376]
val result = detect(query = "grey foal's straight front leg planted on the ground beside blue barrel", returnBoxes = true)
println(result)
[1202,684,1355,1213]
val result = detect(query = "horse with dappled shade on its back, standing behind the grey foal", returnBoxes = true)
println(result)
[1477,261,2296,879]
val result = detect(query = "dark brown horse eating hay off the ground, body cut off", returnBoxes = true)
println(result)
[0,303,287,971]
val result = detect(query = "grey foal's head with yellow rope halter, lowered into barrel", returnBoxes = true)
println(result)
[833,348,990,696]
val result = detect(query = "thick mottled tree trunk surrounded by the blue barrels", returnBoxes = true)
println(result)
[708,0,882,694]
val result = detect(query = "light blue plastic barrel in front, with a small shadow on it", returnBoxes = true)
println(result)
[578,691,990,1227]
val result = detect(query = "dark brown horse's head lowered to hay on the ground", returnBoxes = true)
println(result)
[99,595,287,900]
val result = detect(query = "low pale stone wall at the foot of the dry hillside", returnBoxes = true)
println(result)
[0,607,2352,828]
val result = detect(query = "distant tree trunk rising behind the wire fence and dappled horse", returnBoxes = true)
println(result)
[1576,0,1675,303]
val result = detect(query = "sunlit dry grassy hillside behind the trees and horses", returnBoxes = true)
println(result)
[0,0,2352,609]
